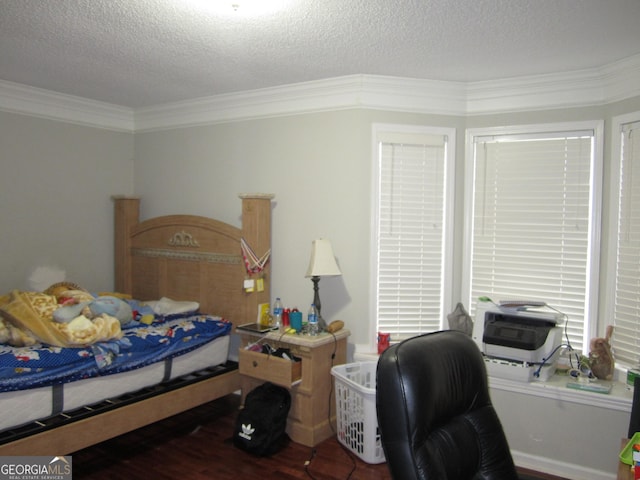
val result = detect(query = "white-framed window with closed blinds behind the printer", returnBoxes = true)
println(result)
[462,122,602,351]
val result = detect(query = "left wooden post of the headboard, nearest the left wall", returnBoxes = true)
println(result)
[112,196,140,294]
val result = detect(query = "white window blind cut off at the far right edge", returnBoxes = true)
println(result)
[613,122,640,366]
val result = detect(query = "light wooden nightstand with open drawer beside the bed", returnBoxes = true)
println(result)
[237,328,351,447]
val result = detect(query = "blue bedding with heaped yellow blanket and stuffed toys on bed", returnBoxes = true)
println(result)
[0,282,231,392]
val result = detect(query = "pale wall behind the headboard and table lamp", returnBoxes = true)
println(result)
[135,111,370,341]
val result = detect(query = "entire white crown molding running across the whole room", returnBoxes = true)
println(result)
[0,55,640,133]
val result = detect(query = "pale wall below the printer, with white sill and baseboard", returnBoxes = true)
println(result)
[490,377,632,480]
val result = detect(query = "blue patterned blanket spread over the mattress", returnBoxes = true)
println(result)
[0,313,231,392]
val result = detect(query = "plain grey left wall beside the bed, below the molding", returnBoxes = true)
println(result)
[0,111,133,294]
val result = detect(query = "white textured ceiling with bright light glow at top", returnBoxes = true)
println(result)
[0,0,640,108]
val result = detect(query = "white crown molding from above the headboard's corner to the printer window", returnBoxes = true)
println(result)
[135,75,465,132]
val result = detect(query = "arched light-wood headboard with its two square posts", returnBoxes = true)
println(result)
[114,194,273,325]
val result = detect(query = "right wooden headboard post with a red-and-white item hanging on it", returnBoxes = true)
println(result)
[240,193,274,322]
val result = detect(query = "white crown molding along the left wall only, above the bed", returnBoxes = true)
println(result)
[0,80,134,132]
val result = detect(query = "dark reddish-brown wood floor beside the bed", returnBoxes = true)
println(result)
[73,395,562,480]
